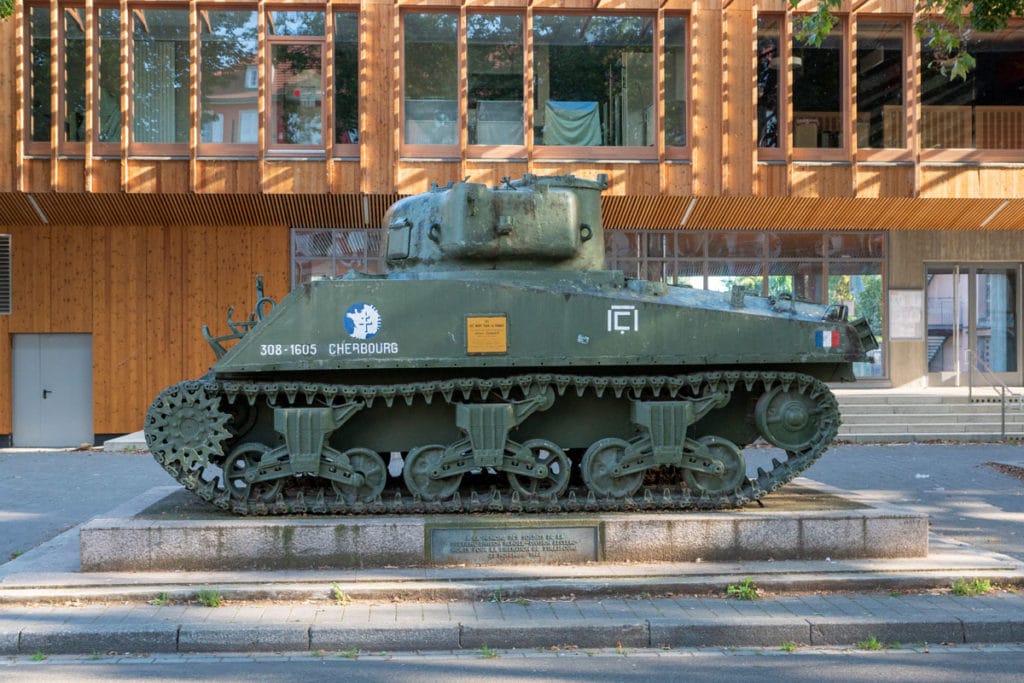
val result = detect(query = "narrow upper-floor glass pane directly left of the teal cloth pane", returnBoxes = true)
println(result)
[466,14,525,144]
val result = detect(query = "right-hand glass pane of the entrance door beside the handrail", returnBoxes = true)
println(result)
[975,268,1017,373]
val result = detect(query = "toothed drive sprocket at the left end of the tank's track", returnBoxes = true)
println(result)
[145,382,230,471]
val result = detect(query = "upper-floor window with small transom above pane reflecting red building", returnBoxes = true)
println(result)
[266,11,327,154]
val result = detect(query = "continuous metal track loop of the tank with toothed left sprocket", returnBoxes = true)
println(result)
[145,371,840,515]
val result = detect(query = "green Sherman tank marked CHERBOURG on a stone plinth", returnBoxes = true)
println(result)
[145,175,877,514]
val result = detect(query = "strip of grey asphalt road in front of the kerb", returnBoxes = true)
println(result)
[6,646,1024,683]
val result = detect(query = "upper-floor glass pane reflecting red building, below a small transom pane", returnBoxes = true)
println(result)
[268,44,324,145]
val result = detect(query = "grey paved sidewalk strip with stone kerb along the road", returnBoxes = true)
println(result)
[0,593,1024,655]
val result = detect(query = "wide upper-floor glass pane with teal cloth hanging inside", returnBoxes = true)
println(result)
[534,14,654,146]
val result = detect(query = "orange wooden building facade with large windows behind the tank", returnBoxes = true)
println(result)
[0,0,1024,443]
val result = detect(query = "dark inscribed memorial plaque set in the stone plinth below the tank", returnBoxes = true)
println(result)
[429,525,600,564]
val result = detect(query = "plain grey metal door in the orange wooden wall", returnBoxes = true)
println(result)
[12,335,93,447]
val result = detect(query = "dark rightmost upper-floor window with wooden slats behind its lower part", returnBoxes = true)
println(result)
[921,27,1024,150]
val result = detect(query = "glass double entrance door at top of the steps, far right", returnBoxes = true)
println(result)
[926,265,1021,386]
